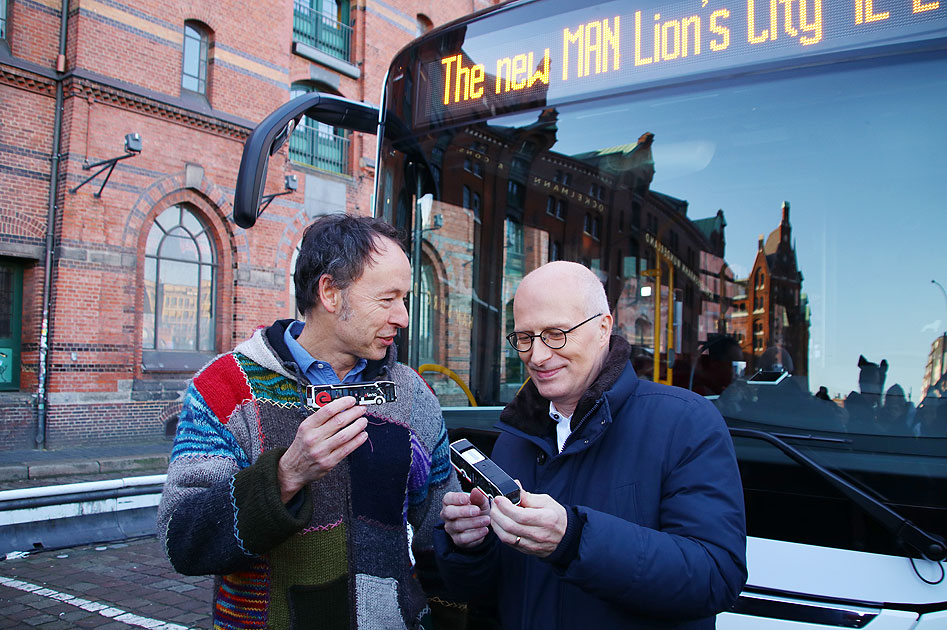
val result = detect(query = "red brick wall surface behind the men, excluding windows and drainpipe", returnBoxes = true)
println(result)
[0,0,493,449]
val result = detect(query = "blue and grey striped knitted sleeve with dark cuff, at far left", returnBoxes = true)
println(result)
[158,384,312,575]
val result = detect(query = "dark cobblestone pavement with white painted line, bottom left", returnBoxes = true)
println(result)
[0,536,213,630]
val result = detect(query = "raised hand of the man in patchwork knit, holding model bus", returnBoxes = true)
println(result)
[277,396,368,503]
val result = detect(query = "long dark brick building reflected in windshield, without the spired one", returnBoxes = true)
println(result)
[383,108,735,405]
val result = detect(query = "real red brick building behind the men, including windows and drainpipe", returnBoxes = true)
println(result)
[0,0,495,449]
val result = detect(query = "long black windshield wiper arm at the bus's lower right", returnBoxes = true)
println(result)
[730,428,947,562]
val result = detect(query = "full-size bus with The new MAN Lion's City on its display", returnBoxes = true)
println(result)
[235,0,947,630]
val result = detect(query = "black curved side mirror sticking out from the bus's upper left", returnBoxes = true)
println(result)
[233,92,378,229]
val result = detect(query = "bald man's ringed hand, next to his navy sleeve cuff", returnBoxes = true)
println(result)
[490,482,569,558]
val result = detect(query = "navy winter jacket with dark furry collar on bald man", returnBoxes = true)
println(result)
[435,337,746,630]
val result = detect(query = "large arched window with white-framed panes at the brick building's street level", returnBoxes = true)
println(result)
[141,205,217,352]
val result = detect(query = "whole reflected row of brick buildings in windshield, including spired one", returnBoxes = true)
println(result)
[408,108,808,400]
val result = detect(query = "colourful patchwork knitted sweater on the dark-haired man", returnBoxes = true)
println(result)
[158,320,459,630]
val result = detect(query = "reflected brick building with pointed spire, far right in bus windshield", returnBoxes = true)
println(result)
[730,201,809,388]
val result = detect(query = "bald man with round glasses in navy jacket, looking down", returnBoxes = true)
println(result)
[435,261,746,630]
